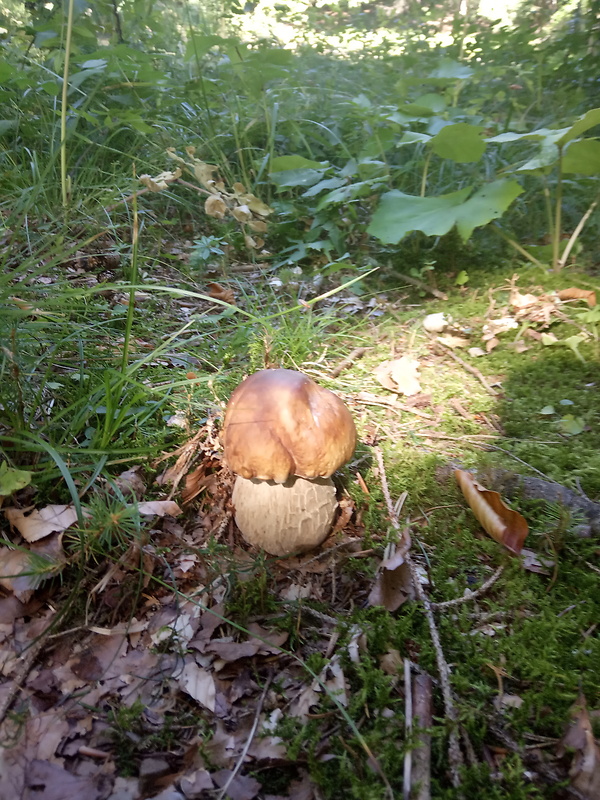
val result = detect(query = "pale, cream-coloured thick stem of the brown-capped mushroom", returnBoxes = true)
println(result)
[231,477,337,556]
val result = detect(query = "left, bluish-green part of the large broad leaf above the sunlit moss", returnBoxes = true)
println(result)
[367,186,472,244]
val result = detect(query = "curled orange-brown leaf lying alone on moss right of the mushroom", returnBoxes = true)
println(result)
[454,469,529,554]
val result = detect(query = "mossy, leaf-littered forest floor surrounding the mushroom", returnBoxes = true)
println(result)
[0,228,600,800]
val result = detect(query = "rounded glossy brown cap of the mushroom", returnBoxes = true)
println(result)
[223,369,356,483]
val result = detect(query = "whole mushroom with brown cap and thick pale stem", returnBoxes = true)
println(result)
[223,369,356,556]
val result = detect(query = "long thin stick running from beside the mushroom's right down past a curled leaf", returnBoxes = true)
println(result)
[373,447,464,789]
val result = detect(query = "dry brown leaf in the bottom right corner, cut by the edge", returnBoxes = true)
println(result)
[559,694,600,800]
